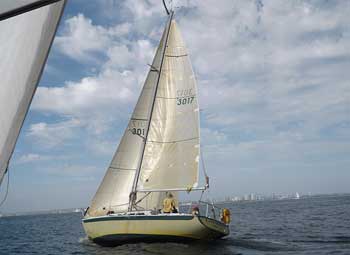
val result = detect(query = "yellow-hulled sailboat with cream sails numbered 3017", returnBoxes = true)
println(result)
[82,2,229,246]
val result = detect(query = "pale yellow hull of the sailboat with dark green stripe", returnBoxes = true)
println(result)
[83,214,229,246]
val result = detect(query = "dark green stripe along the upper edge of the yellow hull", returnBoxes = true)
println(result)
[83,215,193,223]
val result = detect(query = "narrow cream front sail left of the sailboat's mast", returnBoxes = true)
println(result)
[88,16,167,216]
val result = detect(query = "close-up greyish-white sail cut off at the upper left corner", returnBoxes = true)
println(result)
[0,0,65,183]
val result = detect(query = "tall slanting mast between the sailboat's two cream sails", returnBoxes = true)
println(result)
[128,11,174,212]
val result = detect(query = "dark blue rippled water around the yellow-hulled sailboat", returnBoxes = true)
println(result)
[0,195,350,255]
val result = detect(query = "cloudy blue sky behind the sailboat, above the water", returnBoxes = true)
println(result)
[0,0,350,212]
